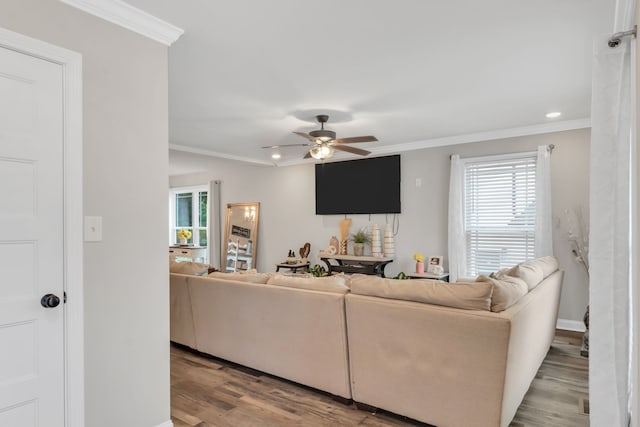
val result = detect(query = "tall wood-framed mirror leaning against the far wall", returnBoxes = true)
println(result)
[220,203,260,272]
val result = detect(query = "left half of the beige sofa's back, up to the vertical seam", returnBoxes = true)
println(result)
[171,273,351,399]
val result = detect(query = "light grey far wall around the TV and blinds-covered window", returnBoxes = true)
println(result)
[170,130,590,321]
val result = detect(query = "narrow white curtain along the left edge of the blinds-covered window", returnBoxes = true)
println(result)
[449,154,467,282]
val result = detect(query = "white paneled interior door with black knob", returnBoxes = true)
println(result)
[0,48,65,427]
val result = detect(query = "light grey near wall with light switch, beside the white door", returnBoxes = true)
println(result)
[0,0,170,427]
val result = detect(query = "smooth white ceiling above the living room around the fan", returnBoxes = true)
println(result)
[127,0,609,164]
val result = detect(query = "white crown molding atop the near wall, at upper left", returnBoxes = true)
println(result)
[60,0,184,46]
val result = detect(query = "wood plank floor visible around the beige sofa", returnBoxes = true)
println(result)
[171,331,589,427]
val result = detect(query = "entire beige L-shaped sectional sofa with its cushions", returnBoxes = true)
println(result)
[171,258,563,427]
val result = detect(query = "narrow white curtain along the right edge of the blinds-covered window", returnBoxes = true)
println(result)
[535,145,553,258]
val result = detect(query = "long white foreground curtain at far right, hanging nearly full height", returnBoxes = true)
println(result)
[589,29,635,427]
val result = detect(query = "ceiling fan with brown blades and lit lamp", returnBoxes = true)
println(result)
[262,114,378,160]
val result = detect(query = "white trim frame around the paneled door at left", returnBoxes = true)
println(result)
[0,27,84,427]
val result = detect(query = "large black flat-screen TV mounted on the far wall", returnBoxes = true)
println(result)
[316,155,400,215]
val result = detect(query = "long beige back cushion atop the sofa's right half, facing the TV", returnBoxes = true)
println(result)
[350,274,493,311]
